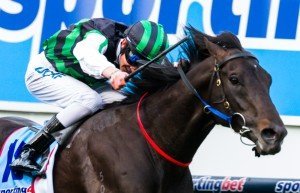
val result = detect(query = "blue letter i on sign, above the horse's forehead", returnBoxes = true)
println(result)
[246,0,271,38]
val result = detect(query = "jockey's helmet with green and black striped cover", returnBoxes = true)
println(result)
[125,20,169,60]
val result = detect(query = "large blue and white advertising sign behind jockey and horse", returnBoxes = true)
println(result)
[0,0,300,116]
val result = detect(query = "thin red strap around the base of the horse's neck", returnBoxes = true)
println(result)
[136,93,190,167]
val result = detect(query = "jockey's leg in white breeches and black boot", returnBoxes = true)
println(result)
[11,53,126,172]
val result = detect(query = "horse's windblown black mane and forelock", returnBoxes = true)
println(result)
[123,26,243,102]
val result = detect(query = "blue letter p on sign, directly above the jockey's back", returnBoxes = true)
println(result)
[41,0,96,50]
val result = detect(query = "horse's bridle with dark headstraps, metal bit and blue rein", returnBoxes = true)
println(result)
[177,52,258,146]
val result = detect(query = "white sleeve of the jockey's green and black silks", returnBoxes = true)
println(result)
[73,30,115,79]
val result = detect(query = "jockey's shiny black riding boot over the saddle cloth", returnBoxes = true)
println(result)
[10,116,65,173]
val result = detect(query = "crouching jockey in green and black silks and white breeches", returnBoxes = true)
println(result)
[10,18,168,173]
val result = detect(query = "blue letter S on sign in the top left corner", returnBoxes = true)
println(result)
[0,0,40,30]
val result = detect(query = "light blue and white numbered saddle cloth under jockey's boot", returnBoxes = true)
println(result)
[0,126,58,193]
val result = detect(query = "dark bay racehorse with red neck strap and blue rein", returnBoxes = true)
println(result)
[0,27,287,193]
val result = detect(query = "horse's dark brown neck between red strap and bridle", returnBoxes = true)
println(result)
[142,58,214,161]
